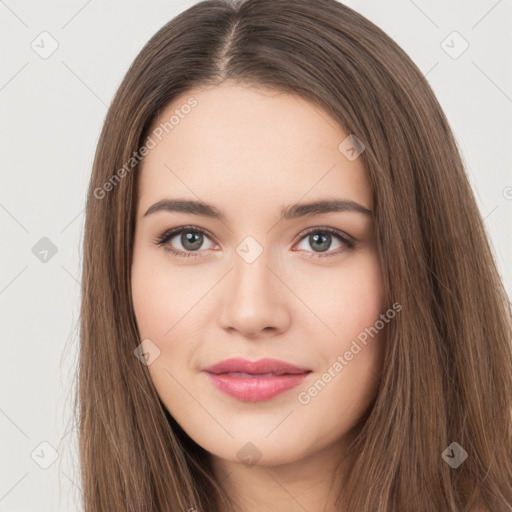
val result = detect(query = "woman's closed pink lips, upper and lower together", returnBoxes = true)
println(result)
[203,358,311,402]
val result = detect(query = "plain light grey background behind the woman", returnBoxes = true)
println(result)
[0,0,512,512]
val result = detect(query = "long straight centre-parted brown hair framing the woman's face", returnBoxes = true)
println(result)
[75,0,512,512]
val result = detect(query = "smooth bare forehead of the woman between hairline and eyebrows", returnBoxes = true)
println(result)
[139,82,372,215]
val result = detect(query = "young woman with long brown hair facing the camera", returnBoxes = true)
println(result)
[77,0,512,512]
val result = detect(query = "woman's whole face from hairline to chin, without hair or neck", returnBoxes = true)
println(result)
[132,82,387,465]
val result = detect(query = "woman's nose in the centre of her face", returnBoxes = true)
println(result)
[219,252,292,338]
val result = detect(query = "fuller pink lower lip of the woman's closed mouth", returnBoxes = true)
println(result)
[206,372,308,402]
